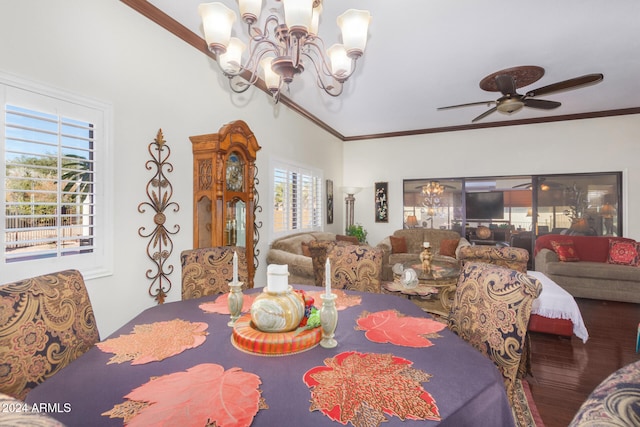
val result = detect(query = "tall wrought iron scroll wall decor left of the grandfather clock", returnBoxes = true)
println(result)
[138,129,180,304]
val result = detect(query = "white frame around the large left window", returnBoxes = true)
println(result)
[0,72,114,282]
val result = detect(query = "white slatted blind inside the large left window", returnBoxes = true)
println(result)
[5,105,95,262]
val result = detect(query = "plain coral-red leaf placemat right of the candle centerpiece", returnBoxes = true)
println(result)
[355,310,446,347]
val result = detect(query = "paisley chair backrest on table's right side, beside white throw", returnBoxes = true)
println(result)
[448,262,542,401]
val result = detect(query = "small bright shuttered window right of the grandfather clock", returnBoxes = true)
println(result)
[272,162,323,235]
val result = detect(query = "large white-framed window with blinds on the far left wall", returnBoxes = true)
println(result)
[0,74,112,281]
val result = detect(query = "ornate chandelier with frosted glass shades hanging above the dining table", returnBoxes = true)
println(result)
[198,0,371,102]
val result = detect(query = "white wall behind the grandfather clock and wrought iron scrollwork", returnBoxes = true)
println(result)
[0,0,342,337]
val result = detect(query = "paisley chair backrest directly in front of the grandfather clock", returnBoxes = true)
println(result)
[180,246,249,300]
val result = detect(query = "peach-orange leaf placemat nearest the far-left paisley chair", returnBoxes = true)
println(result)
[96,319,209,365]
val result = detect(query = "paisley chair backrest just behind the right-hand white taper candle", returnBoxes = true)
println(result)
[327,245,383,293]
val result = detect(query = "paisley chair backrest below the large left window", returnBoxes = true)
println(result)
[0,270,100,399]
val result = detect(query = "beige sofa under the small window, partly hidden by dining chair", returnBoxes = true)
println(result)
[264,231,336,286]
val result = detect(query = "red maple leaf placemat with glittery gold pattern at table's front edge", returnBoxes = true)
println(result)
[303,351,440,427]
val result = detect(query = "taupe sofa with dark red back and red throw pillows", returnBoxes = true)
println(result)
[534,234,640,303]
